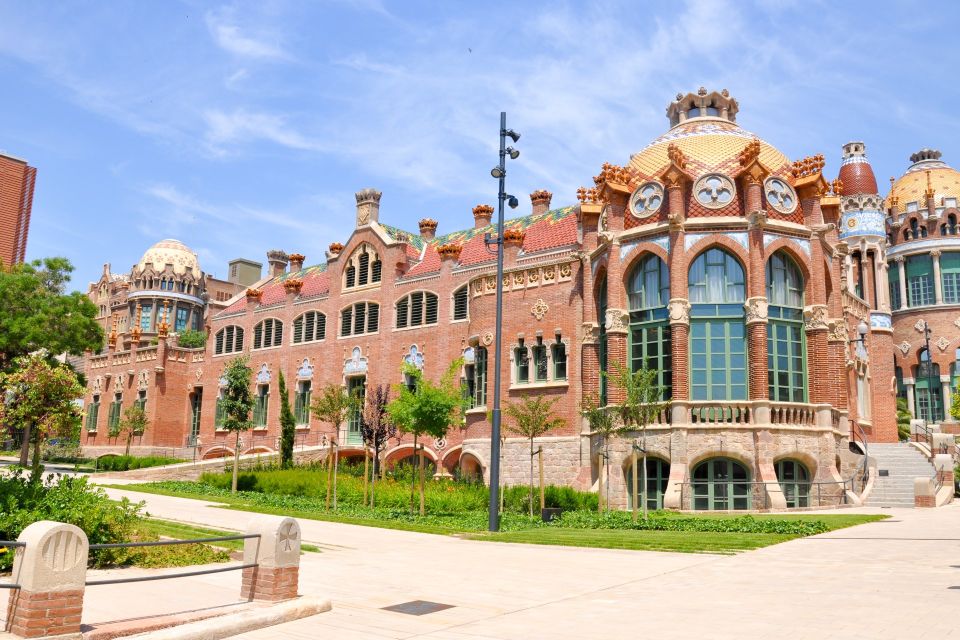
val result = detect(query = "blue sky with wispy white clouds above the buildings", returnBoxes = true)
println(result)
[0,0,960,289]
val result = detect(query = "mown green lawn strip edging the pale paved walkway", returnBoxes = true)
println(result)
[106,483,888,553]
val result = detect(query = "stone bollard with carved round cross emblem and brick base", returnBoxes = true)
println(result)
[240,516,300,602]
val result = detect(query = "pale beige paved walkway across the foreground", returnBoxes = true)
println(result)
[11,482,960,640]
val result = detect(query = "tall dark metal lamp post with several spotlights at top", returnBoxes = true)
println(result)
[483,111,520,531]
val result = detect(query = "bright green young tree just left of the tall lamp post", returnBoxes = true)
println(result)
[387,358,469,515]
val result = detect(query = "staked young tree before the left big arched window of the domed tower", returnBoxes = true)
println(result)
[613,362,670,520]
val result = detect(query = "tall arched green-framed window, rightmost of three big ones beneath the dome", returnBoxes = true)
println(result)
[767,251,807,402]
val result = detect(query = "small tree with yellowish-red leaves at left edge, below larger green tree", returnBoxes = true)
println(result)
[0,350,84,481]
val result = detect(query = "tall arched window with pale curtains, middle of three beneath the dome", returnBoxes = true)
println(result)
[688,248,747,400]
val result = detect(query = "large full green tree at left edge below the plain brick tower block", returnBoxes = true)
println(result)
[0,258,103,371]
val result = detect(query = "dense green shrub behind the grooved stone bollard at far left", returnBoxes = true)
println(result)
[0,468,143,570]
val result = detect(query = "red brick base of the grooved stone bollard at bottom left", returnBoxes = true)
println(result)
[7,589,83,638]
